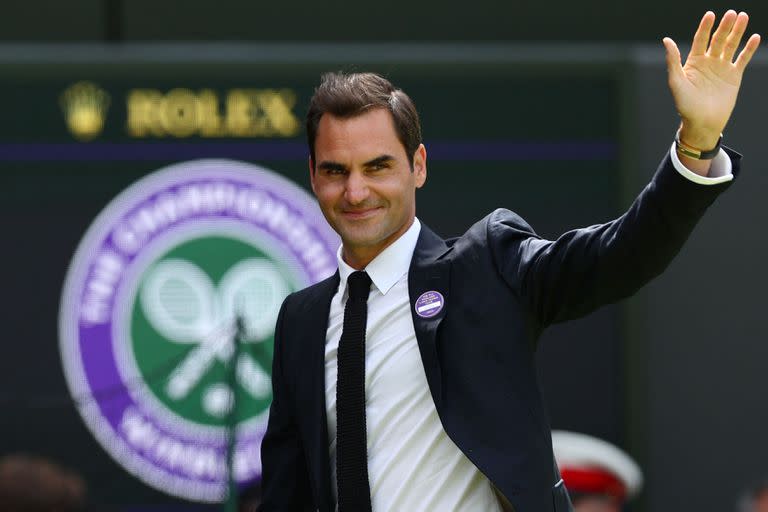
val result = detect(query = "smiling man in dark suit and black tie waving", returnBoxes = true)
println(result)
[262,11,759,512]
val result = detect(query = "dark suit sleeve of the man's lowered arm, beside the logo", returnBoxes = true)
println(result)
[258,300,316,512]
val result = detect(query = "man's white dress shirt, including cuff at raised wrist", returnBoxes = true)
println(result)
[325,145,733,512]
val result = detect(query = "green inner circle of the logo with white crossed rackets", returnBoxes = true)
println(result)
[130,236,295,427]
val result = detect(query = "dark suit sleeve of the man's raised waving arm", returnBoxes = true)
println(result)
[487,149,741,328]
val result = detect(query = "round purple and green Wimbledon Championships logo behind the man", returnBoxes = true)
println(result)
[59,160,339,502]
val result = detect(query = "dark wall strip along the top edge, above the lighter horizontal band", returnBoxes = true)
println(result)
[0,0,768,42]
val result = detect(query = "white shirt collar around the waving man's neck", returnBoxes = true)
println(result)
[336,218,421,296]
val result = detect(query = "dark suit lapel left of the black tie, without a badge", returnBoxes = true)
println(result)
[301,271,339,511]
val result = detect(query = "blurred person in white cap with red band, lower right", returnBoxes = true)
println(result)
[552,430,643,512]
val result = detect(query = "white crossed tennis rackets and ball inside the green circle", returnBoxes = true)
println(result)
[140,258,289,417]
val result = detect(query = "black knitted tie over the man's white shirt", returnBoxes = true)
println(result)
[336,271,371,512]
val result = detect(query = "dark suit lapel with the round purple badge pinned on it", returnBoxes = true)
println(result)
[408,225,450,407]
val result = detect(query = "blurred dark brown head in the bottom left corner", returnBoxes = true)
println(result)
[0,455,86,512]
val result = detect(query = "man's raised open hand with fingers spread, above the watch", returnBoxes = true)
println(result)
[663,11,760,150]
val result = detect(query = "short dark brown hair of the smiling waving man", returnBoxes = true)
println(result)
[307,72,421,167]
